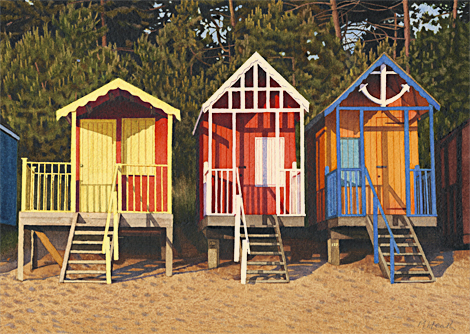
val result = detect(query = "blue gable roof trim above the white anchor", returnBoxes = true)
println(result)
[322,53,441,116]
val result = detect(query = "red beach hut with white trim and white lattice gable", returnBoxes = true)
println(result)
[193,53,309,282]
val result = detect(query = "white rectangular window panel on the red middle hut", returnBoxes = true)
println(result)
[255,137,285,187]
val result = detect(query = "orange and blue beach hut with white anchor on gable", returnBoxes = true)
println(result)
[306,54,440,283]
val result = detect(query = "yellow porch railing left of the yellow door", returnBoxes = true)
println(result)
[21,158,73,212]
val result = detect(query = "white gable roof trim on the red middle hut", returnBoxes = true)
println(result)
[193,52,309,135]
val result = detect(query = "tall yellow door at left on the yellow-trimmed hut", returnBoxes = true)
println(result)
[80,120,116,212]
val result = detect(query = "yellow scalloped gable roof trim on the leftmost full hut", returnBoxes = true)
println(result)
[56,78,181,120]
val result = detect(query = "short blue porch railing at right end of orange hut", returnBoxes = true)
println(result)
[410,165,434,216]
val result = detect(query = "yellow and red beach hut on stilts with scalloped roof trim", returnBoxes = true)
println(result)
[18,79,180,283]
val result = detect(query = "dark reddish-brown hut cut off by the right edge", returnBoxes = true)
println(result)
[437,119,470,247]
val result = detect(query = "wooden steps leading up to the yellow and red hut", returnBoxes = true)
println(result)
[59,219,112,283]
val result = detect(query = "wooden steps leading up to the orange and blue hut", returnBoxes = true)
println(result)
[366,216,436,283]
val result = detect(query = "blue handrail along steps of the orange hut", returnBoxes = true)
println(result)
[365,168,400,284]
